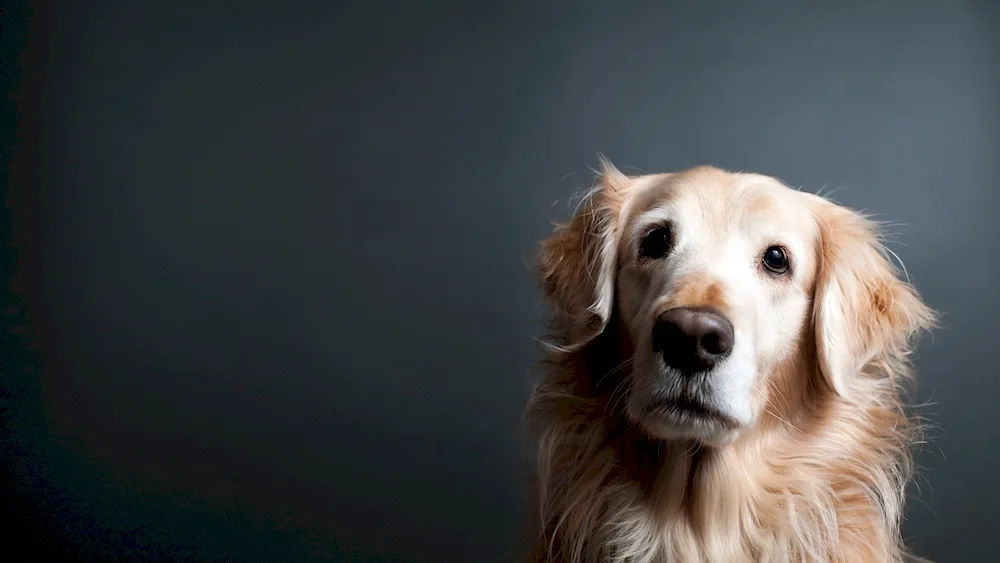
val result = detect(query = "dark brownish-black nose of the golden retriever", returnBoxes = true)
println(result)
[653,307,735,374]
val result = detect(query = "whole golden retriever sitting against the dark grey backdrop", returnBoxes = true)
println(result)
[526,159,936,563]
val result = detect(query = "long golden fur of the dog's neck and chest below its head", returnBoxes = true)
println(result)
[536,340,905,563]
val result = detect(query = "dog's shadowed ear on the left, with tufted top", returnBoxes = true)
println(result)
[539,159,630,348]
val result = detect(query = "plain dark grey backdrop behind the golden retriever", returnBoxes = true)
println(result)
[7,0,1000,562]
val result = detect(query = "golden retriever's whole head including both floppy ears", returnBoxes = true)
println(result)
[541,163,932,445]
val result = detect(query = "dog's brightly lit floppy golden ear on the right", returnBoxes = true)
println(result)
[813,198,935,397]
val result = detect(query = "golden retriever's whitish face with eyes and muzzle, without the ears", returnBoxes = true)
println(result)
[617,169,819,443]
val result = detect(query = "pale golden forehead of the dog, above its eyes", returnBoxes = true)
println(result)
[632,166,815,236]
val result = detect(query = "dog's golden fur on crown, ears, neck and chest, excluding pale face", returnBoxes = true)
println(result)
[526,162,934,563]
